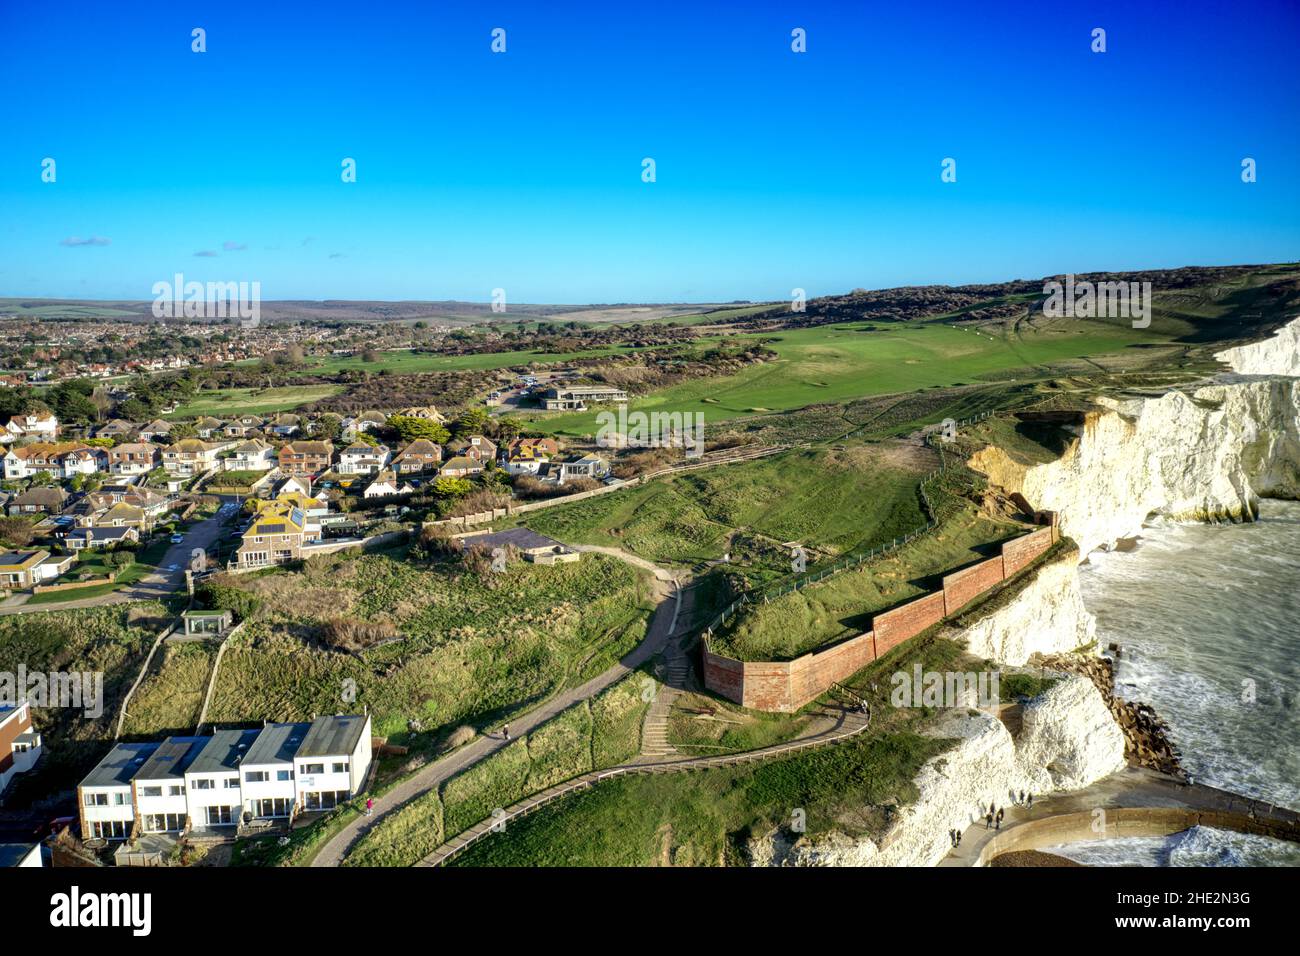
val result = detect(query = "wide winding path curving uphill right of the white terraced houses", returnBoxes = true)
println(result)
[312,548,681,866]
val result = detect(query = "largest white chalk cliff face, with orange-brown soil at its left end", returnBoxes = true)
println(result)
[970,378,1300,554]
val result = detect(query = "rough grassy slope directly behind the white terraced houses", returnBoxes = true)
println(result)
[202,550,653,748]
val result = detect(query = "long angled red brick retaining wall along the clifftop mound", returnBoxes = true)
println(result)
[703,512,1060,713]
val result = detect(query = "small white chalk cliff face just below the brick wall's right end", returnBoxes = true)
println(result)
[945,551,1097,667]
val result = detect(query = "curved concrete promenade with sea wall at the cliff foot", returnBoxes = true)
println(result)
[939,766,1300,866]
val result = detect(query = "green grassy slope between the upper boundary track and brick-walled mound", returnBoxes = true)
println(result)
[527,442,939,578]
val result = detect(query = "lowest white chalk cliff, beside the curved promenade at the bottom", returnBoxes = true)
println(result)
[751,675,1125,866]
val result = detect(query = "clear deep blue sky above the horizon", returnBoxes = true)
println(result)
[0,0,1300,302]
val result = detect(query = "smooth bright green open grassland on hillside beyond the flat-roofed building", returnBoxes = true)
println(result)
[525,321,1165,436]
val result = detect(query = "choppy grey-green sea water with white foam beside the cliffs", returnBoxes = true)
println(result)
[1049,501,1300,866]
